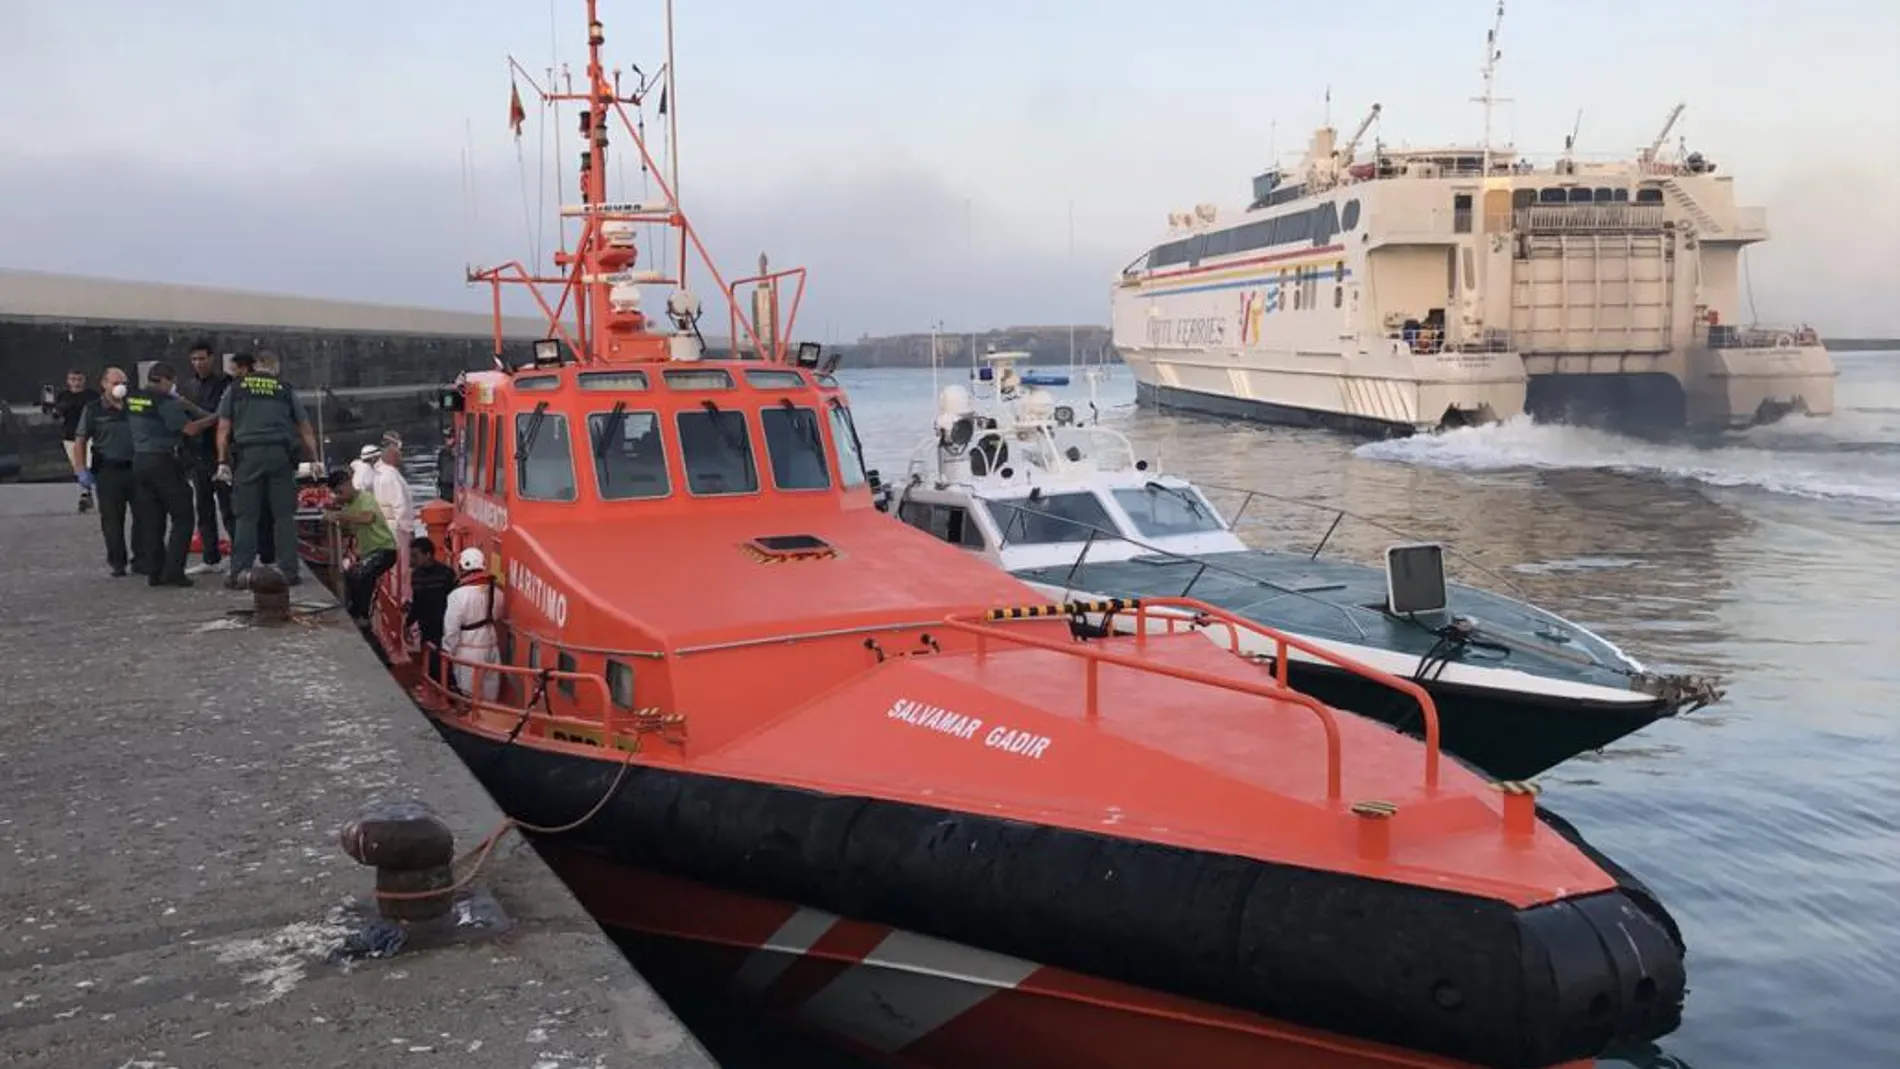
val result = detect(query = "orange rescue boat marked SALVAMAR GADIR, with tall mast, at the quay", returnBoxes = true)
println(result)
[349,0,1685,1069]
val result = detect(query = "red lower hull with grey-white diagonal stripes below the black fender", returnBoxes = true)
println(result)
[554,843,1587,1069]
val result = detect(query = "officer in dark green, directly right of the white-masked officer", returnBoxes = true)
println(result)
[125,361,215,587]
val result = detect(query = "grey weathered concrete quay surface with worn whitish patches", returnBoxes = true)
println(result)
[0,484,713,1069]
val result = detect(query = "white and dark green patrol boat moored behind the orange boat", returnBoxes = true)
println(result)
[889,353,1720,778]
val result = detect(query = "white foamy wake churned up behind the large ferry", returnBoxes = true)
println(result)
[1353,412,1900,505]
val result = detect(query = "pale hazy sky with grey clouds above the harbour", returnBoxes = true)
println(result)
[0,0,1900,340]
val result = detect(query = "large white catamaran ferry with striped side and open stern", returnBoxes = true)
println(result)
[1112,4,1835,435]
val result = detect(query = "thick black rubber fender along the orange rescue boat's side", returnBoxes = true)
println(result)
[423,706,1683,1069]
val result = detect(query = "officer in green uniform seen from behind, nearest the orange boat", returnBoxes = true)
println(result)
[215,353,321,589]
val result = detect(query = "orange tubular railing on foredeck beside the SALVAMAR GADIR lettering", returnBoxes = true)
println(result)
[944,598,1438,801]
